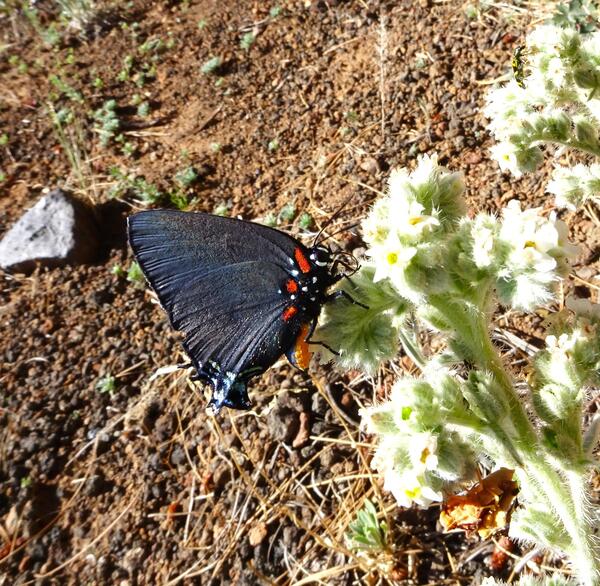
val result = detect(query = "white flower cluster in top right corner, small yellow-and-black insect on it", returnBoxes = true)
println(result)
[484,25,600,209]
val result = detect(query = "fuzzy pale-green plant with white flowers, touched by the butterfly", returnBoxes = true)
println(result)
[319,156,600,585]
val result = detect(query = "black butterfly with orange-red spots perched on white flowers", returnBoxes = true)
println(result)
[128,210,358,413]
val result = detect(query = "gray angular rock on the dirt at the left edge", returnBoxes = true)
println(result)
[0,189,99,272]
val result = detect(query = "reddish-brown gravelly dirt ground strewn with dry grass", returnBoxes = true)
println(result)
[0,0,600,586]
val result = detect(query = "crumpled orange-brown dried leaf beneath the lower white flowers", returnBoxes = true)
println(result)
[440,468,519,539]
